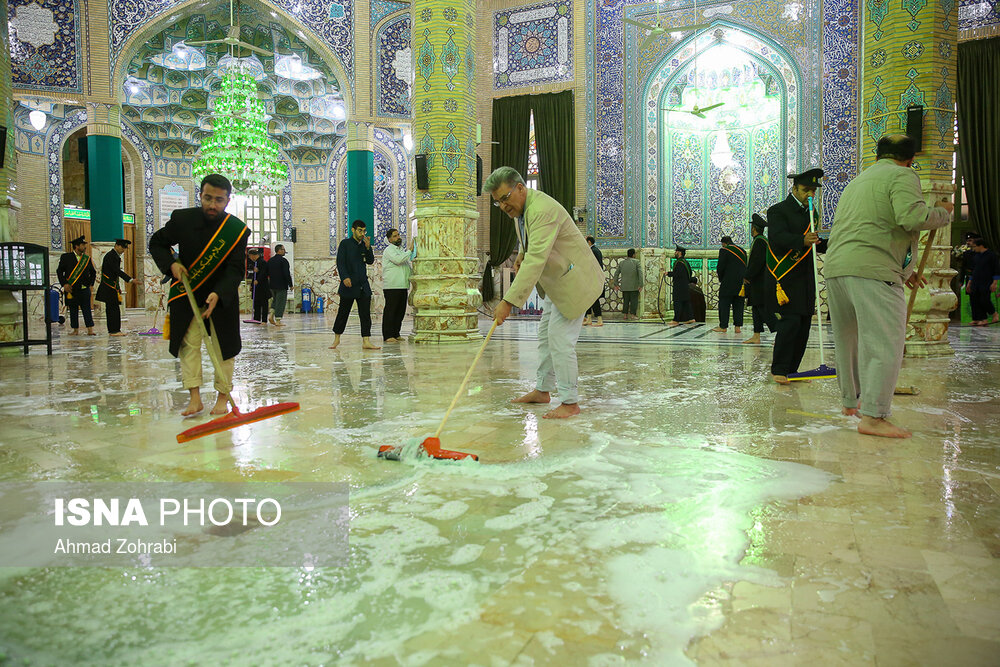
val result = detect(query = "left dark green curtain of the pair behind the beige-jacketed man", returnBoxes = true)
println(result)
[481,95,531,301]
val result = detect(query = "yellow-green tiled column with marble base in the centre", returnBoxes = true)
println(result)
[411,0,482,342]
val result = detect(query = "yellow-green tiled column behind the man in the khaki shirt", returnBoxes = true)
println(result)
[861,0,958,357]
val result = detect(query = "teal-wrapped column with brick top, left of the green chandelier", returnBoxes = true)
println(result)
[87,103,125,242]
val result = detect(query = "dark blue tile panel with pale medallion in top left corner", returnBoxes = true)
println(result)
[7,0,83,93]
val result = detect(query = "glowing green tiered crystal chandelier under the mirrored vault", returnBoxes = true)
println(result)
[192,67,288,195]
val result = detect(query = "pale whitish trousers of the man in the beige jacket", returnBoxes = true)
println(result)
[535,297,583,404]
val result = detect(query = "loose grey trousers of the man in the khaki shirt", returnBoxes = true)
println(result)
[826,276,906,419]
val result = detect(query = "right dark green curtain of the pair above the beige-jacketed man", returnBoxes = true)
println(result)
[531,90,576,214]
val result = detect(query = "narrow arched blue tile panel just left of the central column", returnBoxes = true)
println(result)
[375,14,413,118]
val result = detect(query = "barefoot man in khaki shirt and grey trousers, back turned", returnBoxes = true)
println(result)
[823,134,953,438]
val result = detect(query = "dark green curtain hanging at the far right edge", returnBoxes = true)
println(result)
[957,37,1000,251]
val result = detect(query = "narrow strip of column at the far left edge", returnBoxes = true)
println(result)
[0,0,24,355]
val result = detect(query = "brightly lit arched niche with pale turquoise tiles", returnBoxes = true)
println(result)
[644,22,802,248]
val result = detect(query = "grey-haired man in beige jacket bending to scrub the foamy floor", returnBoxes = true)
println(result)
[483,167,604,419]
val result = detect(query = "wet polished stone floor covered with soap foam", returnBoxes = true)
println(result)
[0,311,1000,667]
